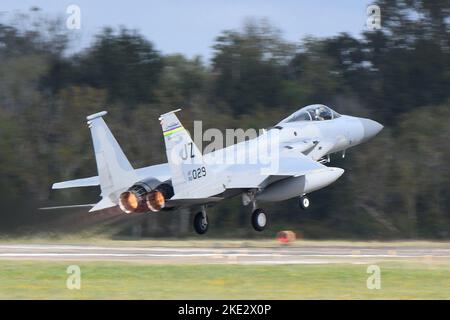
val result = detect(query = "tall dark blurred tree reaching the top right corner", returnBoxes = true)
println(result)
[363,0,450,123]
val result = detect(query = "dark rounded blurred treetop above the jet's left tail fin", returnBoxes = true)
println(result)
[72,28,163,104]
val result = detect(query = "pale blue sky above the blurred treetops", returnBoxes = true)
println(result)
[0,0,370,60]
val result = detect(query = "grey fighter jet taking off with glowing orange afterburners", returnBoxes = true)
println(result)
[45,104,383,234]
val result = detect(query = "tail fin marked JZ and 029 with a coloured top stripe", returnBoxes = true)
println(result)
[159,109,208,196]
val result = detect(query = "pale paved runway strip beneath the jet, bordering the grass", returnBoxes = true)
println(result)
[0,244,450,264]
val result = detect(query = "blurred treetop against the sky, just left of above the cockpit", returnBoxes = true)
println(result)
[212,20,294,115]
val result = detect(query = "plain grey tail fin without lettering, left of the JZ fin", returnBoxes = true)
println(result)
[86,111,138,200]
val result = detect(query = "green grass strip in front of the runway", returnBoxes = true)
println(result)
[0,261,450,299]
